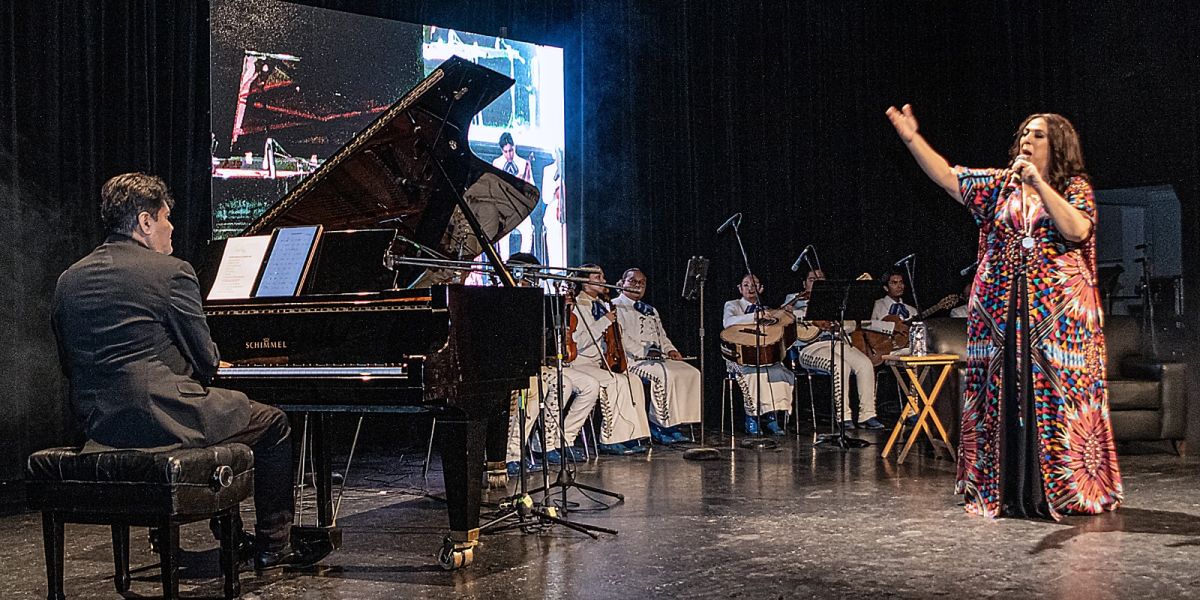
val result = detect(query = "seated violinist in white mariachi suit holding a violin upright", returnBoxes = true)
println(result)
[571,264,650,455]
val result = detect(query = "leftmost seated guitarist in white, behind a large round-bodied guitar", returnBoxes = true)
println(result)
[721,275,796,436]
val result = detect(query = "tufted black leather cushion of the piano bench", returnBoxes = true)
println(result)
[25,444,254,516]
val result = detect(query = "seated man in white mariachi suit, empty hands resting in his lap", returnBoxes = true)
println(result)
[612,269,700,445]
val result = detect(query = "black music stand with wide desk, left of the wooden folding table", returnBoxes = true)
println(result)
[804,280,880,450]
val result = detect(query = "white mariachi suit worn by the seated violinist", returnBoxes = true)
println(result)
[571,294,650,444]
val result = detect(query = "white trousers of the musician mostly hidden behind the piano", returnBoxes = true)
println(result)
[504,367,600,462]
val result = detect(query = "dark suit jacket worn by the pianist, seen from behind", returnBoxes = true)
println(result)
[50,235,250,450]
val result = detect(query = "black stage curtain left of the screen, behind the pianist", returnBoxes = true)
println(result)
[0,0,210,481]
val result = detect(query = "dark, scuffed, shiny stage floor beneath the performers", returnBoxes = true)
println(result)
[0,432,1200,600]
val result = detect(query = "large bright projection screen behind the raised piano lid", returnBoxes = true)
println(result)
[210,0,566,266]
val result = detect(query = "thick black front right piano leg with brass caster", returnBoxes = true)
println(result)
[438,419,487,570]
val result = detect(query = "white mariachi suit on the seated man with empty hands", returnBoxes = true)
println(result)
[612,295,700,427]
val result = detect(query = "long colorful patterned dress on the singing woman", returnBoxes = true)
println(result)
[954,167,1123,520]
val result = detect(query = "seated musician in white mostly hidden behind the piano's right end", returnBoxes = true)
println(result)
[504,252,600,476]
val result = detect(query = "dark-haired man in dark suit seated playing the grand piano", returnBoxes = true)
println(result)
[52,173,322,570]
